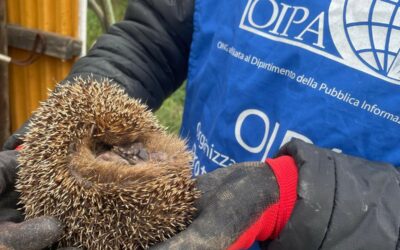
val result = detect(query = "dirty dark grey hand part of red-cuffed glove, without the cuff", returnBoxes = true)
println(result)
[151,162,279,250]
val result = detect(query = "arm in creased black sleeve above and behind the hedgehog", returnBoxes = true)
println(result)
[4,0,194,150]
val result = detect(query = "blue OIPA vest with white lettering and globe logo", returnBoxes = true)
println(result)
[181,0,400,176]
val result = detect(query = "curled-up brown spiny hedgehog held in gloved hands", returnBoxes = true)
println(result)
[17,78,200,249]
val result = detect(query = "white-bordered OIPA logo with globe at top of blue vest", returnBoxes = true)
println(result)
[239,0,400,84]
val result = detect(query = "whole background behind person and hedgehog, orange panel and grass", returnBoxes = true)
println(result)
[0,0,185,145]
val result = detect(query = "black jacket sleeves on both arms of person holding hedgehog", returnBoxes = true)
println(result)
[5,0,400,250]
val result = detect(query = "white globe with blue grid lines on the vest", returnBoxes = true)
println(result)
[342,0,400,80]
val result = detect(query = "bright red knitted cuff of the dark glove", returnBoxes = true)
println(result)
[228,156,298,250]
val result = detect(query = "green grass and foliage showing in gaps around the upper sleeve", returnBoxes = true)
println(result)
[87,0,185,133]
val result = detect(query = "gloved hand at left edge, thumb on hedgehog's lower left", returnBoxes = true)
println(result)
[0,150,62,250]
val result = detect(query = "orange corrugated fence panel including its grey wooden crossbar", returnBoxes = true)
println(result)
[6,0,87,135]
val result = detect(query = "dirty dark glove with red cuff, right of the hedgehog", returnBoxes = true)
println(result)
[152,156,297,249]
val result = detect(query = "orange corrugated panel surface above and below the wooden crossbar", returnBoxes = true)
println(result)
[7,0,86,131]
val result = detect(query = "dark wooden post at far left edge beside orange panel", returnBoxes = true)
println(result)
[0,0,10,146]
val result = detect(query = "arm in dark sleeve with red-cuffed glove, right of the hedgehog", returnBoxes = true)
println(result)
[153,140,400,250]
